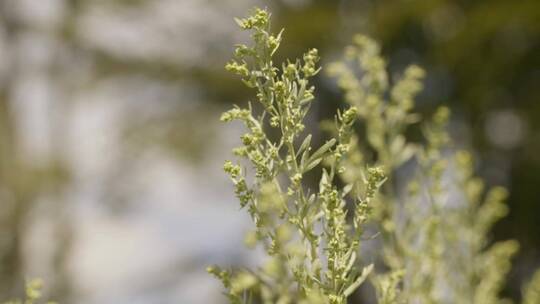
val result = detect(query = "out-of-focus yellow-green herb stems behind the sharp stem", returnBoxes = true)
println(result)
[329,35,540,304]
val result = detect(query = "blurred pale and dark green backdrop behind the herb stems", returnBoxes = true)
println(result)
[0,0,540,304]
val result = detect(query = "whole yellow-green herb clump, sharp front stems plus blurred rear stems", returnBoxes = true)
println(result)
[214,9,540,304]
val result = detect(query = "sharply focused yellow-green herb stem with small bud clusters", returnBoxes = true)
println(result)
[208,9,385,304]
